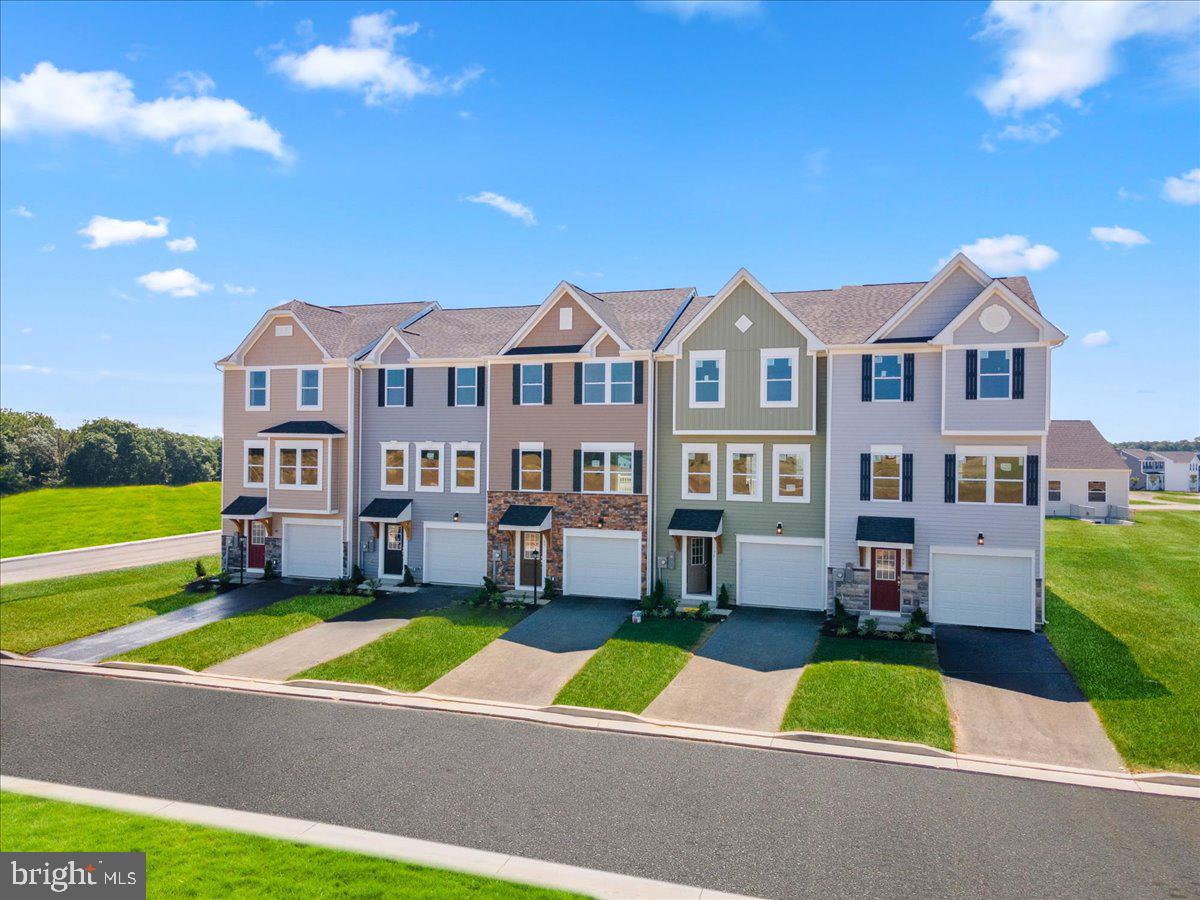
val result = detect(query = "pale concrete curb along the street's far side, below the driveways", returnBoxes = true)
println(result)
[2,652,1200,799]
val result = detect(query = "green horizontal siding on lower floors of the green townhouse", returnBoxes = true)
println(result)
[654,359,826,600]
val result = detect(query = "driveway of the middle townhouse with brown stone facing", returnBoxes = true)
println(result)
[424,598,631,706]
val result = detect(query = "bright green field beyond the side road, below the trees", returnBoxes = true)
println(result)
[0,481,221,558]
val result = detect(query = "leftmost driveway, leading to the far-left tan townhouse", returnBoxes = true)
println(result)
[30,578,311,662]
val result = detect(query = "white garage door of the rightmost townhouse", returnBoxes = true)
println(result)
[929,550,1033,631]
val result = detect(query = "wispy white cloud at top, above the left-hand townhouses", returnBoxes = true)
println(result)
[271,10,484,106]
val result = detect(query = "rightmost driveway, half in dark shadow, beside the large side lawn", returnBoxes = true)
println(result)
[937,625,1124,769]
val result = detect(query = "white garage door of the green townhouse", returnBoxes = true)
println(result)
[737,536,826,610]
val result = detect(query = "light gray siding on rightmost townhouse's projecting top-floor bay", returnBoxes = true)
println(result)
[940,347,1050,433]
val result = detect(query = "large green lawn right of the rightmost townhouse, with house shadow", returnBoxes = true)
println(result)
[1046,510,1200,772]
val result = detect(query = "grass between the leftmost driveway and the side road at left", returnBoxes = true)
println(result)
[0,556,217,653]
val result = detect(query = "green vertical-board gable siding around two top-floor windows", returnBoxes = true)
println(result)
[664,283,814,433]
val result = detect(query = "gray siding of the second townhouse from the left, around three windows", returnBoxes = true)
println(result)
[354,362,492,580]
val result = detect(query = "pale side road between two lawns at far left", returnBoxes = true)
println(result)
[0,532,221,584]
